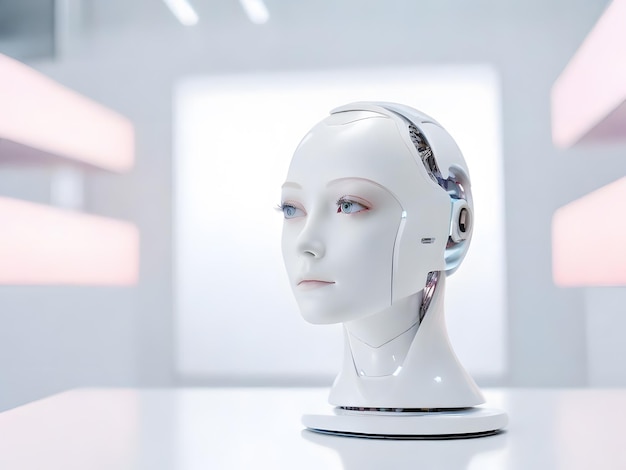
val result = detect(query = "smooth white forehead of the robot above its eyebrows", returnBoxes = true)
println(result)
[287,111,421,193]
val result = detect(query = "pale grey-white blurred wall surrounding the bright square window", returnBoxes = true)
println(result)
[0,0,626,408]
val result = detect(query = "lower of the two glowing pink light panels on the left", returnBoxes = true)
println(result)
[0,197,139,286]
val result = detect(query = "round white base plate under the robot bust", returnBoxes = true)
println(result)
[302,407,508,439]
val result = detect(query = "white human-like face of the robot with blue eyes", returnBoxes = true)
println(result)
[281,115,402,323]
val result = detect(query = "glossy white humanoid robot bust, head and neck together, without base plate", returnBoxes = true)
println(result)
[281,102,503,436]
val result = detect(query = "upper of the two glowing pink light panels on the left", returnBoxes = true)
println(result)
[0,54,134,172]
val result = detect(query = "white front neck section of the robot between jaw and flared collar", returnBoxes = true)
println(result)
[344,292,422,377]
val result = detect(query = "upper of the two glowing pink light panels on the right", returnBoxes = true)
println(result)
[552,0,626,147]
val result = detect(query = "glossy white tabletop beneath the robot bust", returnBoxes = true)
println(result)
[0,388,626,470]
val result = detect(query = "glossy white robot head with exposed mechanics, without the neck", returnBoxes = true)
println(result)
[282,102,473,323]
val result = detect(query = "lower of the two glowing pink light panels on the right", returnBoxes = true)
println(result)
[552,178,626,287]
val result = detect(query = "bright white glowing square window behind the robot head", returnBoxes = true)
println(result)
[174,66,506,380]
